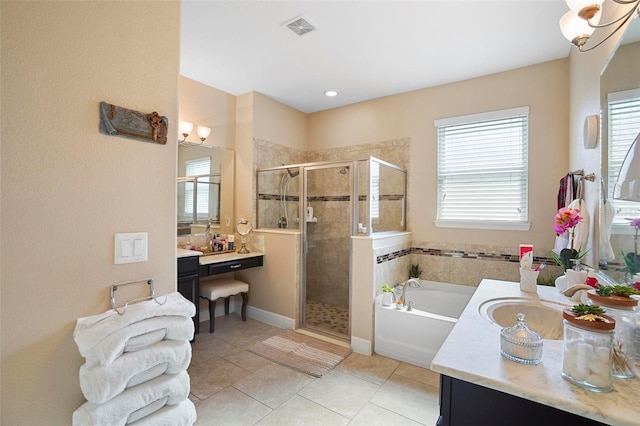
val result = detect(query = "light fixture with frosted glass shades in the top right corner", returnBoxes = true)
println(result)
[560,0,640,52]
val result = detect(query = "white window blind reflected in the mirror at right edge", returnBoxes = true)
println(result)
[607,88,640,225]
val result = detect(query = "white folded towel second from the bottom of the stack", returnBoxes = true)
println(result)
[72,371,189,426]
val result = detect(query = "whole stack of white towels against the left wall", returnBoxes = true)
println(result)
[73,292,196,425]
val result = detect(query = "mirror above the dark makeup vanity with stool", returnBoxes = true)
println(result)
[176,145,235,237]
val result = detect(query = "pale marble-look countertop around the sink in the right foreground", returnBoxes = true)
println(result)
[431,279,640,425]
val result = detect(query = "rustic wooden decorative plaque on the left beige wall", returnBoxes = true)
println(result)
[100,102,168,145]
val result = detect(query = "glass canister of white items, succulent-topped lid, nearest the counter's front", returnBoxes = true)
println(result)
[562,309,616,392]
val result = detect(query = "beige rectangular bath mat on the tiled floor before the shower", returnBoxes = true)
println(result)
[248,331,351,377]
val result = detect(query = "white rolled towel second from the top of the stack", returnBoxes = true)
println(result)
[80,314,194,367]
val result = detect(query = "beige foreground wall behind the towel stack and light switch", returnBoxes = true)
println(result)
[0,1,180,425]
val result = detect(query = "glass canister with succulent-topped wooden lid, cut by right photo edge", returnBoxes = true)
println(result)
[587,290,638,379]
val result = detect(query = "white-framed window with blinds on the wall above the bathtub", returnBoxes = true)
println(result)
[434,107,529,230]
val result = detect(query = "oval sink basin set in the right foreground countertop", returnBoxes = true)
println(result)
[478,297,568,340]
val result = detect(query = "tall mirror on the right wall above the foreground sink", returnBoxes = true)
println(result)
[599,17,640,283]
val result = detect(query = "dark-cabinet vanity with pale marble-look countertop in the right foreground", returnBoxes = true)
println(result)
[431,279,640,426]
